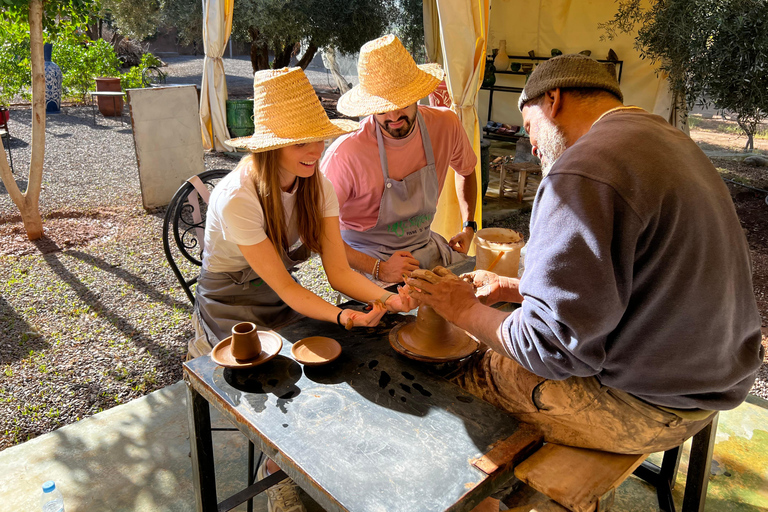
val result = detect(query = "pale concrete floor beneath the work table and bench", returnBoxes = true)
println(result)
[0,382,768,512]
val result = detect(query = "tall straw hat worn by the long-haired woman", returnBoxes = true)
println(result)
[226,68,359,153]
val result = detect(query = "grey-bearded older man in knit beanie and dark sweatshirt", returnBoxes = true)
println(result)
[407,51,764,453]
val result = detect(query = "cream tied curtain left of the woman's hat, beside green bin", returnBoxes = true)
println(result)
[200,0,234,151]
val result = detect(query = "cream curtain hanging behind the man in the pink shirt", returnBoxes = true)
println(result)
[424,0,490,250]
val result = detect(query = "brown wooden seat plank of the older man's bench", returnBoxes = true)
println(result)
[515,443,647,512]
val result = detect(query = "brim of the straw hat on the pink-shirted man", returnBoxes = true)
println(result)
[336,64,444,117]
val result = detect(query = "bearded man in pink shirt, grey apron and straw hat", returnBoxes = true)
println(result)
[321,35,477,283]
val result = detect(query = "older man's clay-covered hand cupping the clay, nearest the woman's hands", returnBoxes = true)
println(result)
[406,267,478,324]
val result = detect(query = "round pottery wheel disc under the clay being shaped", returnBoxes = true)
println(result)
[389,316,479,363]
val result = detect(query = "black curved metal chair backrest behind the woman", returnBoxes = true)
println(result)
[163,169,230,304]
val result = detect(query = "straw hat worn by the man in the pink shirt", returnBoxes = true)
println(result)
[336,34,443,117]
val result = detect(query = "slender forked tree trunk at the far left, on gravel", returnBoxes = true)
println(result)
[0,0,45,240]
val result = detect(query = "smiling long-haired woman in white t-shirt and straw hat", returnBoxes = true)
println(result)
[191,68,411,355]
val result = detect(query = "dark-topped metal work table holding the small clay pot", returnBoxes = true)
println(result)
[184,262,541,512]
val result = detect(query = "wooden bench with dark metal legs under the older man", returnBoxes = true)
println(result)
[510,414,718,512]
